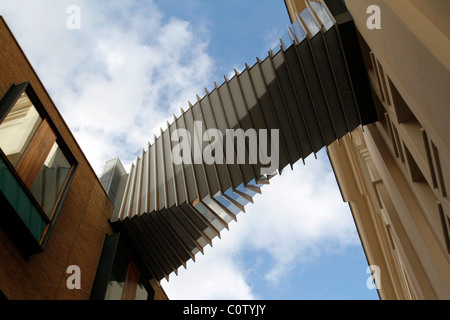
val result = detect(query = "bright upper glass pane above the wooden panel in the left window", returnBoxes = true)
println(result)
[0,92,42,166]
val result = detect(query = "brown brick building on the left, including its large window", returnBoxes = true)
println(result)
[0,18,113,300]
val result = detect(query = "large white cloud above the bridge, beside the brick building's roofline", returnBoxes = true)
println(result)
[2,0,213,171]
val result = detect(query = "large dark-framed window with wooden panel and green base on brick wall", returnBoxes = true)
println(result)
[0,83,76,255]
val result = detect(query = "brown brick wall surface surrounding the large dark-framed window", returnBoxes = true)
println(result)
[0,17,113,300]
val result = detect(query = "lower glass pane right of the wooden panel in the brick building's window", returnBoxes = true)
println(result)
[31,142,71,218]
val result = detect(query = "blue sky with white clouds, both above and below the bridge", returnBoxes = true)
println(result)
[0,0,378,300]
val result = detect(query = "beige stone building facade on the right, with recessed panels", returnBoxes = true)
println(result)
[285,0,450,299]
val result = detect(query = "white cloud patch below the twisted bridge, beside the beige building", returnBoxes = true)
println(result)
[163,151,359,299]
